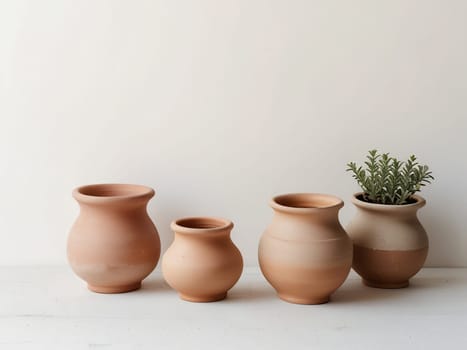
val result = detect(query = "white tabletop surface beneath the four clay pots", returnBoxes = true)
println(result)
[0,266,467,350]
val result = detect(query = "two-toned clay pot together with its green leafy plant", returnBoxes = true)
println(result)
[346,150,434,288]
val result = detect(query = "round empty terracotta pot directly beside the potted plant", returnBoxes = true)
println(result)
[258,193,352,304]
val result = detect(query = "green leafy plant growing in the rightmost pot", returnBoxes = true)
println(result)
[347,150,434,205]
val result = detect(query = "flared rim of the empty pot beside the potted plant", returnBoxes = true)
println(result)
[270,193,344,214]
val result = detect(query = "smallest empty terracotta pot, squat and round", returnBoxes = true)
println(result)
[162,217,243,302]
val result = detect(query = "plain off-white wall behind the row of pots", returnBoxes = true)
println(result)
[0,0,467,266]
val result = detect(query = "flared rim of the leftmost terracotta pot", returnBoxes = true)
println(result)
[73,183,155,203]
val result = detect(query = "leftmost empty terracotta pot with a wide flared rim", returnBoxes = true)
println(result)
[68,184,160,293]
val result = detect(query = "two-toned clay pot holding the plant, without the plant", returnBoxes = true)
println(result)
[347,193,428,288]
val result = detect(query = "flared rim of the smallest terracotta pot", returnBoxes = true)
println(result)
[170,216,234,234]
